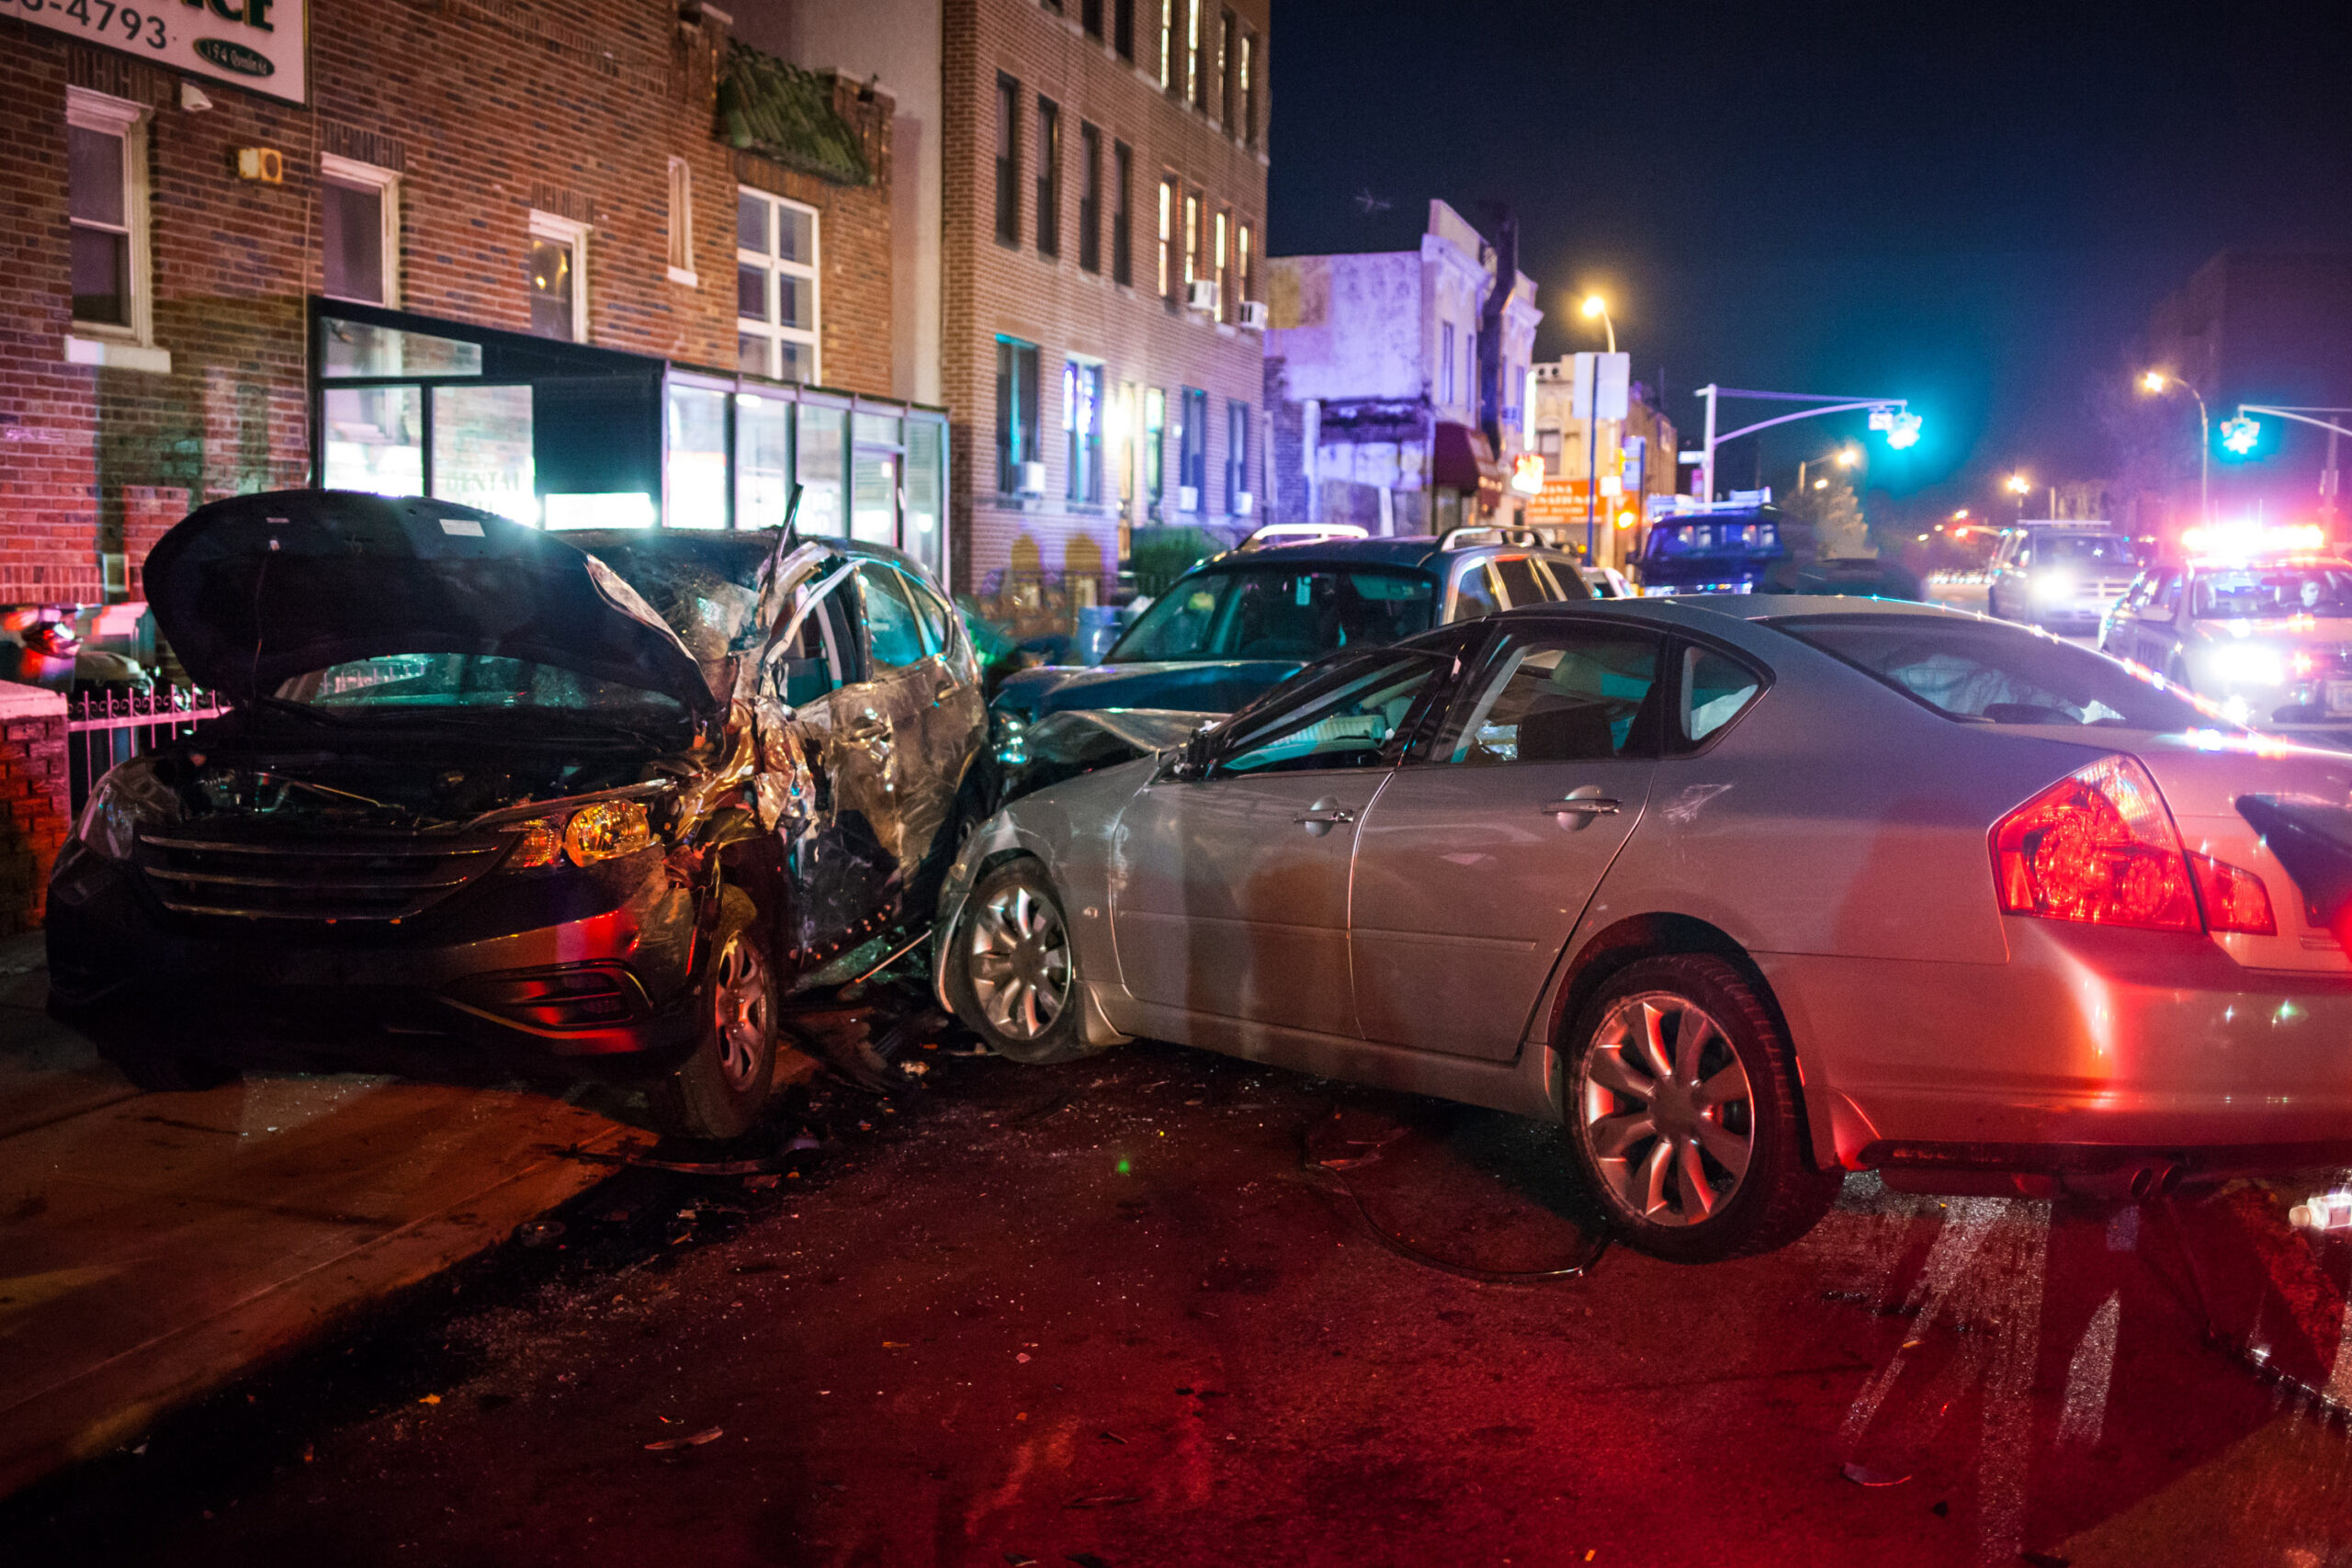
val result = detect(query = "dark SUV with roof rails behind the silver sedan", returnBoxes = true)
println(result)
[992,529,1590,795]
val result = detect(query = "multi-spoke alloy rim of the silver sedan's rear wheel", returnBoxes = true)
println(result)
[1576,992,1755,1224]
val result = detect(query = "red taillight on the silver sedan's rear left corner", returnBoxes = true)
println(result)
[1992,757,2204,931]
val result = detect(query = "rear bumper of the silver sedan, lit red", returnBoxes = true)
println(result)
[1757,917,2352,1170]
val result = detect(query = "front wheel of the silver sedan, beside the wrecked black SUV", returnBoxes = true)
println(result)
[944,858,1101,1065]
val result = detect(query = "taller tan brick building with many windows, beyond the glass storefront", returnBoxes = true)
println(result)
[941,0,1270,623]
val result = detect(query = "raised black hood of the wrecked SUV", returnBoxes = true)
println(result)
[146,489,718,715]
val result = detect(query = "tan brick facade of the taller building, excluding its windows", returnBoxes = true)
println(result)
[941,0,1270,592]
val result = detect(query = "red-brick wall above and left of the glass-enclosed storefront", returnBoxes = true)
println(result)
[0,0,891,604]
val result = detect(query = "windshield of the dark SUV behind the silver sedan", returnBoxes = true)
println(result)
[1103,567,1437,665]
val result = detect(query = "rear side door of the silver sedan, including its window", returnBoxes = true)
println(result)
[1348,618,1668,1058]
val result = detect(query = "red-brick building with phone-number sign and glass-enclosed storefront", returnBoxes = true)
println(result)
[0,0,945,639]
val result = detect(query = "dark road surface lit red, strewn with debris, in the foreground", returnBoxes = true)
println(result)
[0,1039,2352,1568]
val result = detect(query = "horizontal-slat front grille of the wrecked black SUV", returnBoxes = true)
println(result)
[139,829,508,924]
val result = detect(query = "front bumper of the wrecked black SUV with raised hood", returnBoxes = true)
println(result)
[47,851,701,1077]
